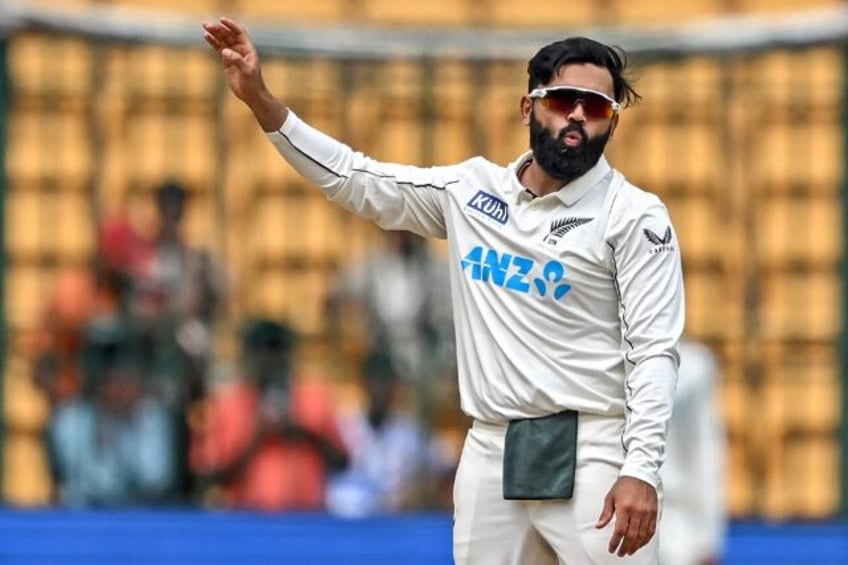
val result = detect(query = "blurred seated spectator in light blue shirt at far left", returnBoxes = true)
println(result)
[50,319,176,506]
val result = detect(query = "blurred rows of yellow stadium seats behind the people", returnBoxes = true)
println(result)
[4,0,845,517]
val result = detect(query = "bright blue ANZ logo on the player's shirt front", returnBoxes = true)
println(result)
[460,245,571,300]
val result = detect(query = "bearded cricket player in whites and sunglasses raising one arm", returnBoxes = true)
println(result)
[203,18,684,565]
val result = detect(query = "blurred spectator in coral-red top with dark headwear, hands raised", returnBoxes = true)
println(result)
[191,320,347,511]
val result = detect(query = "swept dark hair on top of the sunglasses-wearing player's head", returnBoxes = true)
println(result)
[527,37,641,106]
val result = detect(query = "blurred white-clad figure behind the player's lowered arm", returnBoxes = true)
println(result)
[659,339,727,565]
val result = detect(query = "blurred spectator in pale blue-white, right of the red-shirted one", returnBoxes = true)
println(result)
[327,351,429,517]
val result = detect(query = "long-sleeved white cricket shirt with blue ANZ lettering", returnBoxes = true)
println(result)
[268,112,684,486]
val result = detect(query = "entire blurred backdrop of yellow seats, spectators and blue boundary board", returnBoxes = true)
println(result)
[0,0,848,563]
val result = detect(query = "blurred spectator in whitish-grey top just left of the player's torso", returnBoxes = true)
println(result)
[327,230,458,470]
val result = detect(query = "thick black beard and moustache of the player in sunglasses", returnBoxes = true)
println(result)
[530,113,612,183]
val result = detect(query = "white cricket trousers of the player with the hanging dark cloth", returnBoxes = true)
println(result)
[453,414,657,565]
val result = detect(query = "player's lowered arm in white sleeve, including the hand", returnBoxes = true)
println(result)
[598,200,685,556]
